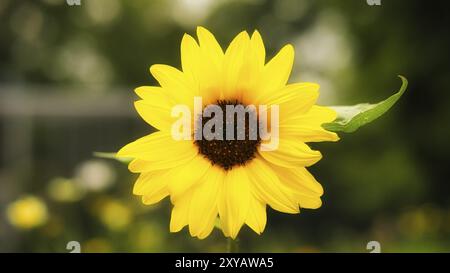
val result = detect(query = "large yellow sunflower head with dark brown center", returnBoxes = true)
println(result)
[117,27,339,239]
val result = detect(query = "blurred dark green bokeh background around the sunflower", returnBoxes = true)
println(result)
[0,0,450,252]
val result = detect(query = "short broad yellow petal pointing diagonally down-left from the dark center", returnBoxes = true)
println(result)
[168,155,212,202]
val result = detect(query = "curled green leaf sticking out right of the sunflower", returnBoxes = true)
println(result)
[322,75,408,133]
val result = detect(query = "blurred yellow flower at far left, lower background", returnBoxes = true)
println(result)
[6,196,48,229]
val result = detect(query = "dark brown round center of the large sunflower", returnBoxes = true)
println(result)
[194,100,261,170]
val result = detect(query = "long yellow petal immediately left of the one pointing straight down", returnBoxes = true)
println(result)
[189,167,225,239]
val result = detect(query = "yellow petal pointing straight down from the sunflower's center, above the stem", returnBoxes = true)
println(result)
[218,167,252,239]
